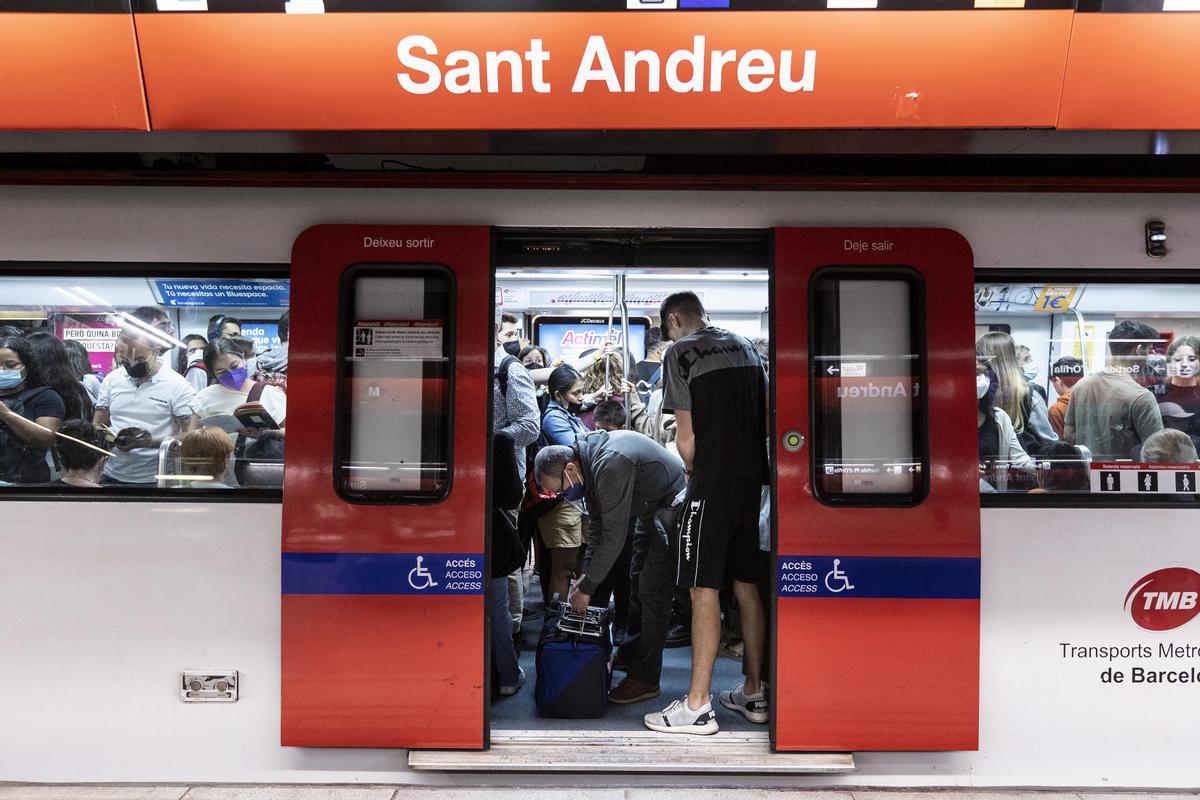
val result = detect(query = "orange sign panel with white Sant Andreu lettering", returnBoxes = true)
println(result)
[136,10,1074,131]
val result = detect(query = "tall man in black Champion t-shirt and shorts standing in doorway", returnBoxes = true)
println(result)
[646,291,768,734]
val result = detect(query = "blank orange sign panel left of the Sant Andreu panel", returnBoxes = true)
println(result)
[0,13,150,131]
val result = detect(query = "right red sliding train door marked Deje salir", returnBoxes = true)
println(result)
[772,229,979,751]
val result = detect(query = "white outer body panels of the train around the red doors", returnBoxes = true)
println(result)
[0,187,1200,787]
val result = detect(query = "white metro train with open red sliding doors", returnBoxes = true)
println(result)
[0,186,1200,786]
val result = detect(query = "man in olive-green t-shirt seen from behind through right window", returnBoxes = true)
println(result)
[1063,319,1163,462]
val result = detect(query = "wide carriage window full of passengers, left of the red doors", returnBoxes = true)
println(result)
[0,270,290,495]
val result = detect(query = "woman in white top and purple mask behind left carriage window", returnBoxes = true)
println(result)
[192,339,288,462]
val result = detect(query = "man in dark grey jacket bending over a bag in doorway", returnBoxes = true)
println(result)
[534,431,684,703]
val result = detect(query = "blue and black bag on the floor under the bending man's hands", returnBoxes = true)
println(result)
[534,602,612,720]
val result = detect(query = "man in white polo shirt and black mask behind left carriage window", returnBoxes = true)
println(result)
[92,324,196,486]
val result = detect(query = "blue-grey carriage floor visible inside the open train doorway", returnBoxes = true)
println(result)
[492,576,767,732]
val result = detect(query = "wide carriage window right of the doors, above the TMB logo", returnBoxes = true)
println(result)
[976,276,1200,501]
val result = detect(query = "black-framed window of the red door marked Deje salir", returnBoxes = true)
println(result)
[810,267,928,505]
